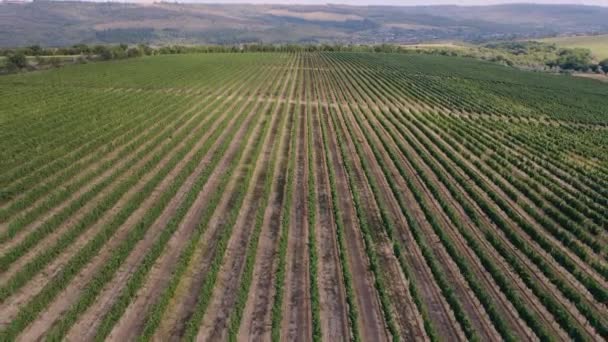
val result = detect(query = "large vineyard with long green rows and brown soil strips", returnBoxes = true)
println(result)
[0,52,608,341]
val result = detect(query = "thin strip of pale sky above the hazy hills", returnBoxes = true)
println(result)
[185,0,608,5]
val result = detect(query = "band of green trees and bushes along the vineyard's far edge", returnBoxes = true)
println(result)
[0,42,608,73]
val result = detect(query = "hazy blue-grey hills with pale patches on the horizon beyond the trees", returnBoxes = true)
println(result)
[0,1,608,47]
